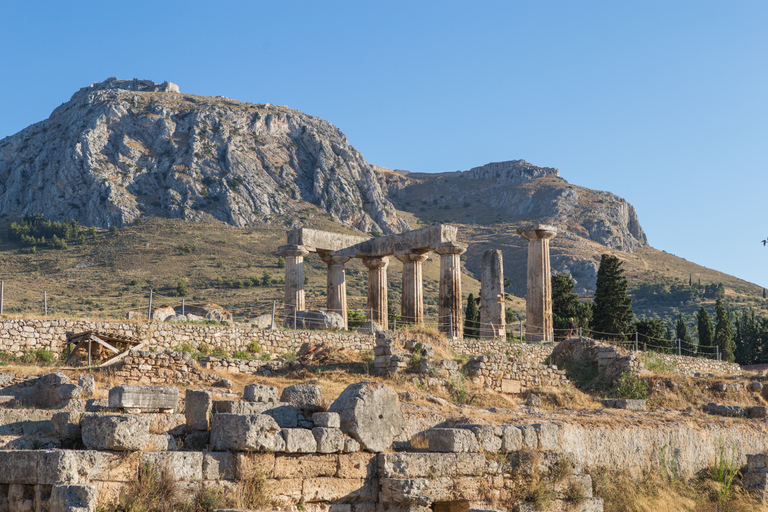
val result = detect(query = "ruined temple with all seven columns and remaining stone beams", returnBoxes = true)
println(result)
[279,224,557,342]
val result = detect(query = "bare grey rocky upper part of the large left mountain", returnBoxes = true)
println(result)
[0,78,408,233]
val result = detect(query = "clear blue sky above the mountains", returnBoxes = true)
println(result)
[0,0,768,287]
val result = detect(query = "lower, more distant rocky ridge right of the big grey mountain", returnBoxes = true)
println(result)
[387,160,648,252]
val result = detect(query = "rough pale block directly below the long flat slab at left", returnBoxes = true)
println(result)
[80,414,150,451]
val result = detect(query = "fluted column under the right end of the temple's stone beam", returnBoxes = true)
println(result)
[435,242,467,338]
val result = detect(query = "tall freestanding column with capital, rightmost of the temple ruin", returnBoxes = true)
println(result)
[517,224,557,342]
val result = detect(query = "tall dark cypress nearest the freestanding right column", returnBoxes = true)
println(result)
[592,254,634,340]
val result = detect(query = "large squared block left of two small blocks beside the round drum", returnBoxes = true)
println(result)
[211,414,285,452]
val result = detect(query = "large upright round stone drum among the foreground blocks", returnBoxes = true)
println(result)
[328,382,405,452]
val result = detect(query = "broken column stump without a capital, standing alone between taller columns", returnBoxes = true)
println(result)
[480,249,507,340]
